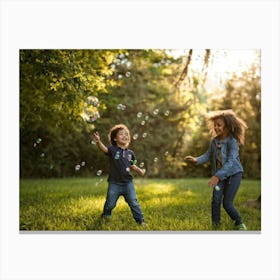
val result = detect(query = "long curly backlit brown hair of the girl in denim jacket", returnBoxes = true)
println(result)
[207,109,248,145]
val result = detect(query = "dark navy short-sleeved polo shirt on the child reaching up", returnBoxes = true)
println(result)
[106,145,136,183]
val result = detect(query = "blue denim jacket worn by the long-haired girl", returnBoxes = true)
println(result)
[196,136,243,181]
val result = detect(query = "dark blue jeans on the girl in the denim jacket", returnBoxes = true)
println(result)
[212,172,242,225]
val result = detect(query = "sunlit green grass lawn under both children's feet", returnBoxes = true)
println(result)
[20,178,261,231]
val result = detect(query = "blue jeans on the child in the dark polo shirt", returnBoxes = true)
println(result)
[102,181,144,223]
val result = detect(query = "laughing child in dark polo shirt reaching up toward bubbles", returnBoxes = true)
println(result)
[93,124,146,226]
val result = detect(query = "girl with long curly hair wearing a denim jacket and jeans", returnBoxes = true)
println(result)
[185,110,247,230]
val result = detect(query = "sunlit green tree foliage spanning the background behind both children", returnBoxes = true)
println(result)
[19,50,261,178]
